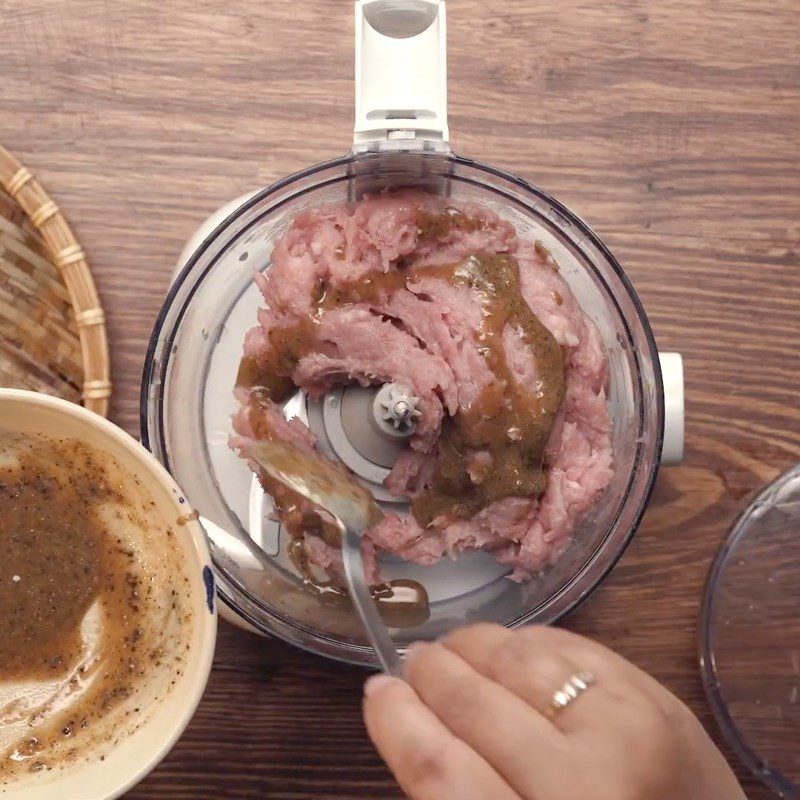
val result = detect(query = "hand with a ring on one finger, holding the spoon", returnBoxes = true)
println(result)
[364,625,744,800]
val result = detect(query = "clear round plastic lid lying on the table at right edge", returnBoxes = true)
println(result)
[700,465,800,798]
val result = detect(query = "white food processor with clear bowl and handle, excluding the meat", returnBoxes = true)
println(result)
[141,0,683,665]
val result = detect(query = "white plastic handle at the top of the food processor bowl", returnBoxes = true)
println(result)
[353,0,449,147]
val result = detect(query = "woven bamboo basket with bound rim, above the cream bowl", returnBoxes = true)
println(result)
[0,146,111,416]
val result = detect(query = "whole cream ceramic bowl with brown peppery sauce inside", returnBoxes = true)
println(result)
[0,389,216,800]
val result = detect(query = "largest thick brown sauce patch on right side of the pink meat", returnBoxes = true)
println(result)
[411,254,564,526]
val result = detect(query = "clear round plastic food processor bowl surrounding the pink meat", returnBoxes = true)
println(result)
[141,152,664,664]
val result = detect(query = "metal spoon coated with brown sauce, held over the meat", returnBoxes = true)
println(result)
[247,440,402,677]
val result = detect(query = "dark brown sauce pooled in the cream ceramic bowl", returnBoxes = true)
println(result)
[0,446,117,680]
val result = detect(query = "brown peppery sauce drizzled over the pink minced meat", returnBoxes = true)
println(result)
[237,209,565,526]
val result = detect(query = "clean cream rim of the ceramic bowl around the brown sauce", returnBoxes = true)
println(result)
[0,389,217,800]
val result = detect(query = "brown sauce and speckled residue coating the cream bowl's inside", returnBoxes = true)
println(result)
[0,430,193,780]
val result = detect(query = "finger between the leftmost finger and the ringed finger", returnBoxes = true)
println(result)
[405,644,567,797]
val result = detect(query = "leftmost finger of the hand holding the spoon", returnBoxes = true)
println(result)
[364,675,520,800]
